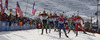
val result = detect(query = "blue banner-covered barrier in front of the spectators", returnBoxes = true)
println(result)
[0,21,36,31]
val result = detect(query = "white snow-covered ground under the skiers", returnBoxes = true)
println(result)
[0,29,100,40]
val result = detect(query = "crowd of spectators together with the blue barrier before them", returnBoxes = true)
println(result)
[0,13,36,31]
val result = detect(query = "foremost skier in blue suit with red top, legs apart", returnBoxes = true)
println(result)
[58,15,68,38]
